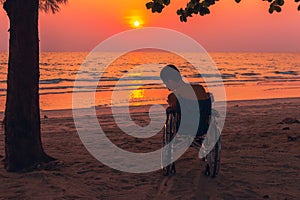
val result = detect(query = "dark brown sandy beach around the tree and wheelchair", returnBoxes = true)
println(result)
[0,98,300,199]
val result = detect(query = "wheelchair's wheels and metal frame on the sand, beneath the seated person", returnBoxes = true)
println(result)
[161,93,221,177]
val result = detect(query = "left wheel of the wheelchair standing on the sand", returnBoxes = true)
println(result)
[161,109,176,176]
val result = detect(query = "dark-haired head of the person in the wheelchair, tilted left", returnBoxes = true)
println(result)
[160,65,182,90]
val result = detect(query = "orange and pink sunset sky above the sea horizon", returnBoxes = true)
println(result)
[0,0,300,52]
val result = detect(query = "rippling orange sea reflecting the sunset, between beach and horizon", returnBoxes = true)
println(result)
[0,51,300,111]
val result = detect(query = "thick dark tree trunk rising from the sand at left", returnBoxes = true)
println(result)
[3,0,52,171]
